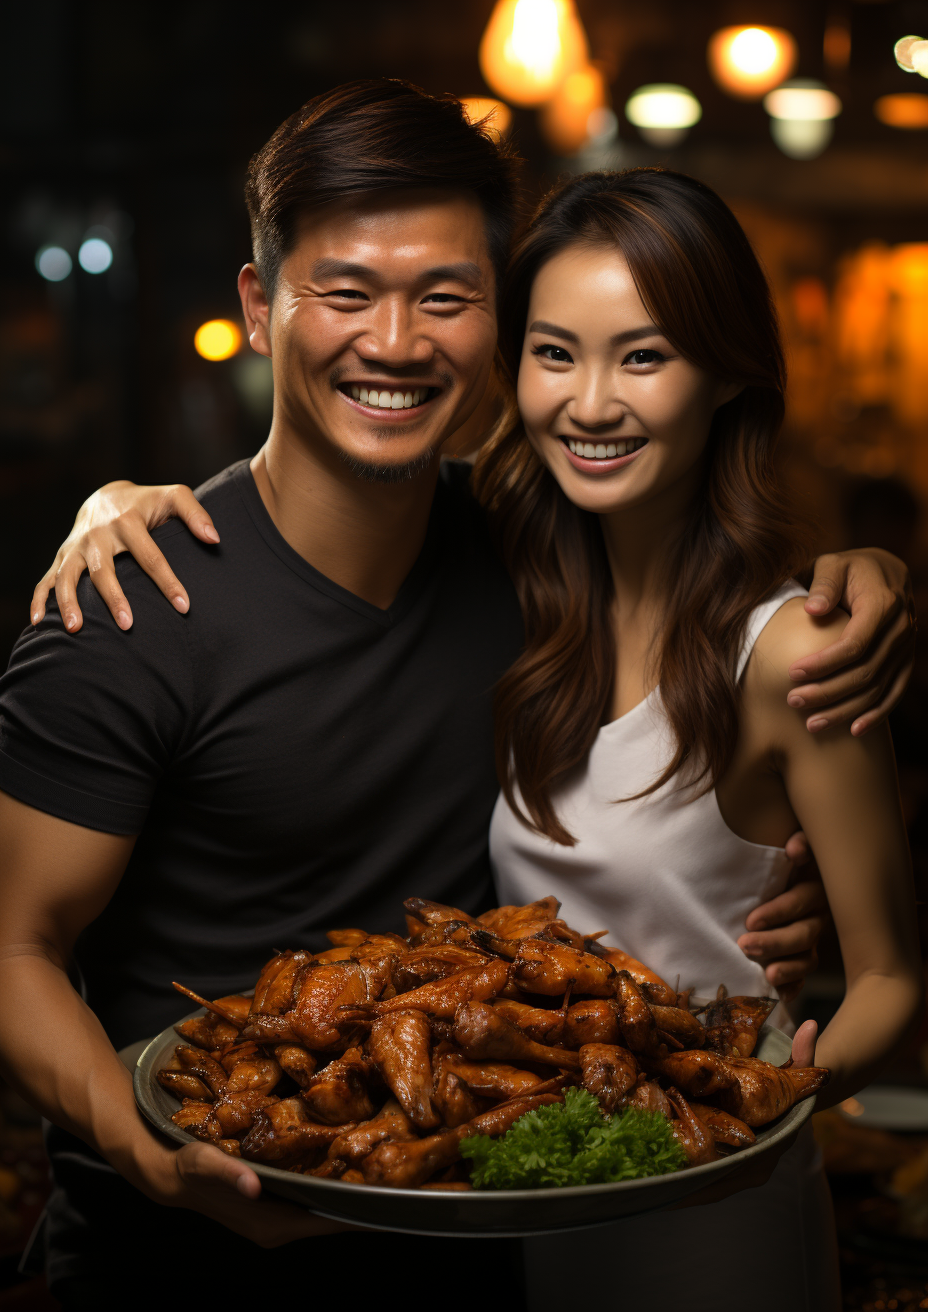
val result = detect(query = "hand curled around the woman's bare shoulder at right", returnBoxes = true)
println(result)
[786,547,916,736]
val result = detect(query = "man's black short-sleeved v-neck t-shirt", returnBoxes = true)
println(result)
[0,462,522,1047]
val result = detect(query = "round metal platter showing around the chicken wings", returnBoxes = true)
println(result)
[134,1010,815,1239]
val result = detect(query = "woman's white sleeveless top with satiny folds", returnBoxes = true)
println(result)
[490,583,807,1012]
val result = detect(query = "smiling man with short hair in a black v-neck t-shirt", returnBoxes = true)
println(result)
[0,83,913,1307]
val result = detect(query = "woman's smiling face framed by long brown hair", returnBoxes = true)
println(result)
[518,243,739,514]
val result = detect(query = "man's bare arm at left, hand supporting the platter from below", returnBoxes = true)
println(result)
[0,792,344,1246]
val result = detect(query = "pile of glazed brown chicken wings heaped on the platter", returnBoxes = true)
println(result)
[158,897,828,1189]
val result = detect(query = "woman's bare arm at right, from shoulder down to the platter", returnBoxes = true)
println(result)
[744,602,923,1102]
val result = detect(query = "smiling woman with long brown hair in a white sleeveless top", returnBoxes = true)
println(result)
[475,169,920,1309]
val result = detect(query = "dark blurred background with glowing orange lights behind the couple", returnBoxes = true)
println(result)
[0,0,928,1309]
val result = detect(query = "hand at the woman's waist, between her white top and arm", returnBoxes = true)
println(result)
[738,833,828,1001]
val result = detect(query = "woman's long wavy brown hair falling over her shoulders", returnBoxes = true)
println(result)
[474,168,807,846]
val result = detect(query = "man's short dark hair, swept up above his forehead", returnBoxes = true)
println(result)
[245,77,518,297]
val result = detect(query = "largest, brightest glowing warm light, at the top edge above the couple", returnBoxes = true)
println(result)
[480,0,588,105]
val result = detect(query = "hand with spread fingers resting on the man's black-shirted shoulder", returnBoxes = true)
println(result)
[29,482,219,634]
